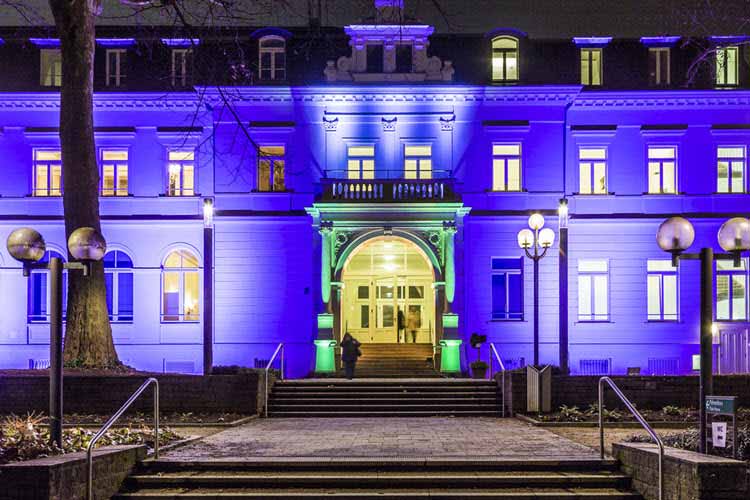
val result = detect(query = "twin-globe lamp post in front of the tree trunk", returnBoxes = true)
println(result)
[7,227,107,449]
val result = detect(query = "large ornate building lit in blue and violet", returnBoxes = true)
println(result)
[0,2,750,376]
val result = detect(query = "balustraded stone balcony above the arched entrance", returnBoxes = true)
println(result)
[318,179,460,203]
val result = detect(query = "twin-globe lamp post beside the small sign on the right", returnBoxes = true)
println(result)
[656,217,750,453]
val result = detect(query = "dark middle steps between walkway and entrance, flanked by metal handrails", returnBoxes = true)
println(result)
[268,378,501,418]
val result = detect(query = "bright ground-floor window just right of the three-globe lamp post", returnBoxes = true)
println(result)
[578,259,609,321]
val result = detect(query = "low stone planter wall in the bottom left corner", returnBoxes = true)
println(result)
[0,445,146,500]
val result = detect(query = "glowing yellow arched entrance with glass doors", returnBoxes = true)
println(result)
[340,236,436,344]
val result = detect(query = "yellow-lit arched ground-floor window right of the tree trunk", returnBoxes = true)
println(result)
[161,250,200,322]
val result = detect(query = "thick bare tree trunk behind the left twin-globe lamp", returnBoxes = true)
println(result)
[49,0,120,368]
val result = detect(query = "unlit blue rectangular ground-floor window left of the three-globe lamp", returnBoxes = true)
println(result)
[492,257,523,320]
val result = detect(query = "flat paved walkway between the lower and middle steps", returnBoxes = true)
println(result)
[164,417,598,461]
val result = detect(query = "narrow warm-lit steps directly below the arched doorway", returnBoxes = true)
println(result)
[354,343,440,378]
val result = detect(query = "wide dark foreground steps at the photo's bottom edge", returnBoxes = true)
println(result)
[113,457,642,500]
